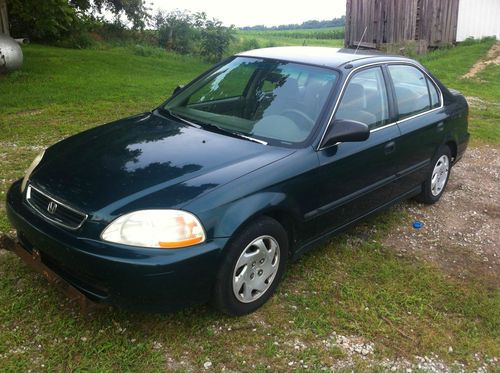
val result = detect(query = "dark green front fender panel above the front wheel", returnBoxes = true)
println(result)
[183,149,318,246]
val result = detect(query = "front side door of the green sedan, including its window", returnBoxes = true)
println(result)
[312,66,399,234]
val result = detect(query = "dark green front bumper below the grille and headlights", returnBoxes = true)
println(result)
[7,181,227,310]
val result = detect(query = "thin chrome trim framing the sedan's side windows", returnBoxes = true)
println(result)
[316,60,444,151]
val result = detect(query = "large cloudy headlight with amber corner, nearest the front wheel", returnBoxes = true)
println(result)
[101,210,205,249]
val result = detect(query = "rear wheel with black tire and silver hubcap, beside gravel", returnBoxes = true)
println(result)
[416,145,452,205]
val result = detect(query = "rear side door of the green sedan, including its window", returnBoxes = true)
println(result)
[387,64,447,194]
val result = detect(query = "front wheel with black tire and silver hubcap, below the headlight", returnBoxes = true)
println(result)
[213,217,288,316]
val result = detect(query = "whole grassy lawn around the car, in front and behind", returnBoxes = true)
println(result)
[0,39,500,372]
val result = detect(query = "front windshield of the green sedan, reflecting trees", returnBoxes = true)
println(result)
[164,57,337,145]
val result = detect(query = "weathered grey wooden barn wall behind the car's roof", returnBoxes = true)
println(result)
[345,0,459,50]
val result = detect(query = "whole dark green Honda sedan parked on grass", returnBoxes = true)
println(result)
[7,47,469,315]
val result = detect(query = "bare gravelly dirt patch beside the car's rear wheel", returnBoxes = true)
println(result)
[384,145,500,287]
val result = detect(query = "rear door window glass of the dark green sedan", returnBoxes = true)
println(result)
[388,65,432,119]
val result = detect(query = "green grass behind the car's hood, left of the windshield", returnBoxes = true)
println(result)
[0,45,209,232]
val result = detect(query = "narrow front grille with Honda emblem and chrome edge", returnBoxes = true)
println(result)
[26,185,87,229]
